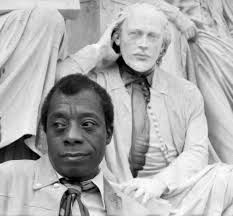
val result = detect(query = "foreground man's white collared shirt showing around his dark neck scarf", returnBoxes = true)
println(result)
[57,171,107,216]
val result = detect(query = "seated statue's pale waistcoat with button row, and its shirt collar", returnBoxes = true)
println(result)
[120,64,177,177]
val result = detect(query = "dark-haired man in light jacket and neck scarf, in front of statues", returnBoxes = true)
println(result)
[0,75,168,216]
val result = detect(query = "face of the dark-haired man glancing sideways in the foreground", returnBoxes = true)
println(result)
[47,90,112,180]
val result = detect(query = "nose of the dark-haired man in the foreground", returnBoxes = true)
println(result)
[65,122,83,145]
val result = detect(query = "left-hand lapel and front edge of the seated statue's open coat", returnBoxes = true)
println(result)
[103,64,132,181]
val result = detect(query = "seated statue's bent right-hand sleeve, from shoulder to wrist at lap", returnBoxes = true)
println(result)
[155,86,210,192]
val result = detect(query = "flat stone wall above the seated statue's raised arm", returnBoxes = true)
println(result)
[66,0,132,53]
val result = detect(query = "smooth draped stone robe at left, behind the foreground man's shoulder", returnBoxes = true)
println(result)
[0,8,65,160]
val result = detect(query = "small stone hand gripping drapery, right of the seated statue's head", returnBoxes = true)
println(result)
[175,12,197,40]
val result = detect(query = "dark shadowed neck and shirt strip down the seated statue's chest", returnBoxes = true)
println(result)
[118,59,157,177]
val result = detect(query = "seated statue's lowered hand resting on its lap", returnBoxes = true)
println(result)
[121,178,167,204]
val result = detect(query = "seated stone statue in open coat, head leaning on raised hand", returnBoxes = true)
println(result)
[58,4,233,216]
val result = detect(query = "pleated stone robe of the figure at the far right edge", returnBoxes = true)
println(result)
[167,0,233,163]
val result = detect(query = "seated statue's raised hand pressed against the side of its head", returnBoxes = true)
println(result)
[96,15,125,67]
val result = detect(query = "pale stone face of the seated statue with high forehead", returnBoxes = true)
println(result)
[119,5,164,72]
